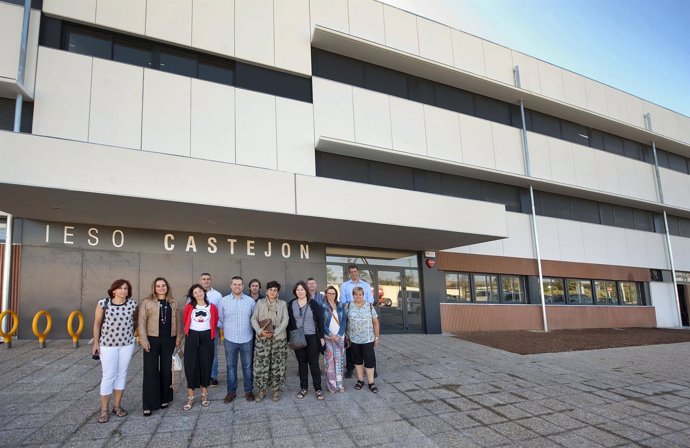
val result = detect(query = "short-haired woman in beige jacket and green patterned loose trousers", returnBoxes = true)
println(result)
[252,280,288,401]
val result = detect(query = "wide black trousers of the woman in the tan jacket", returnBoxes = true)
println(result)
[142,336,175,411]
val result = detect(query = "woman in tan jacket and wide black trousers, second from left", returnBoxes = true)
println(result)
[139,277,182,417]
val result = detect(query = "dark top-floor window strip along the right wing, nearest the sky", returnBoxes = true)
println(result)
[312,48,690,174]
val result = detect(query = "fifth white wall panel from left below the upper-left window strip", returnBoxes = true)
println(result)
[235,89,278,170]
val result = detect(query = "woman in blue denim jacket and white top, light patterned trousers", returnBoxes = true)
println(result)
[323,286,347,394]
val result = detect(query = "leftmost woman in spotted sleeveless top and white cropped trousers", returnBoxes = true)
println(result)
[91,279,137,423]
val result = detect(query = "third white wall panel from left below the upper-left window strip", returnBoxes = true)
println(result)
[141,69,192,156]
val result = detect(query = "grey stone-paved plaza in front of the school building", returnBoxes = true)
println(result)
[0,335,690,448]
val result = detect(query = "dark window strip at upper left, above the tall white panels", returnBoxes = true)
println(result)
[39,17,312,102]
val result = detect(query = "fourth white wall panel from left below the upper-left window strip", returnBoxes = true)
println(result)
[191,79,235,163]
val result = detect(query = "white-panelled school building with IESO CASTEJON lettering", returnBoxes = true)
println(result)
[0,0,690,337]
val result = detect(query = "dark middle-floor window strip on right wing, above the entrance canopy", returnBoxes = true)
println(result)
[316,151,660,237]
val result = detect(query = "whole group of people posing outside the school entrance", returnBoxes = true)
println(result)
[92,265,379,423]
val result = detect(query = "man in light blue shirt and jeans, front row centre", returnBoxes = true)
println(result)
[218,276,255,403]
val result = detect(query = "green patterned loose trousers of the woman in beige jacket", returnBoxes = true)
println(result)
[254,338,287,391]
